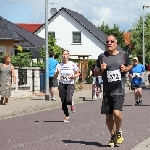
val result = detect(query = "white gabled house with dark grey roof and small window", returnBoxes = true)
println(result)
[34,7,106,59]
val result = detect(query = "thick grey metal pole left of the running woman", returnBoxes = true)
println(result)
[45,0,49,101]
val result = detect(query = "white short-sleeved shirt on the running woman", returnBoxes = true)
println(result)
[56,61,79,84]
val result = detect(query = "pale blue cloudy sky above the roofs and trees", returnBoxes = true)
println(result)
[0,0,150,31]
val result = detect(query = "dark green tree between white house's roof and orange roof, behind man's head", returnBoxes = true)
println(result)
[98,22,129,51]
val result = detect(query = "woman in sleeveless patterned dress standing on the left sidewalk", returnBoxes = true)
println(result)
[0,55,16,105]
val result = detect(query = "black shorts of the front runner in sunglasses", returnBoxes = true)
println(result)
[101,95,124,114]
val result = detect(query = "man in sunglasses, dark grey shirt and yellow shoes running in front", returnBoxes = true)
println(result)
[97,35,132,147]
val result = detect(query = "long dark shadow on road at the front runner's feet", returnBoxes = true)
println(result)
[62,140,109,147]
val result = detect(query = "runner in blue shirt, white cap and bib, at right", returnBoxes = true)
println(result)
[130,57,145,106]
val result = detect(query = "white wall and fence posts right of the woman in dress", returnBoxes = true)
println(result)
[11,67,40,97]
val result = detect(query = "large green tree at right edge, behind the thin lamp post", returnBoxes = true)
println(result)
[130,13,150,64]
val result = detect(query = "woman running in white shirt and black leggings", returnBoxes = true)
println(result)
[54,50,79,122]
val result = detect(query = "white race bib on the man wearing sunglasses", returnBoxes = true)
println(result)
[107,70,121,82]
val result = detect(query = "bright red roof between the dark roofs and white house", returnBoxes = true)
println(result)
[16,23,42,33]
